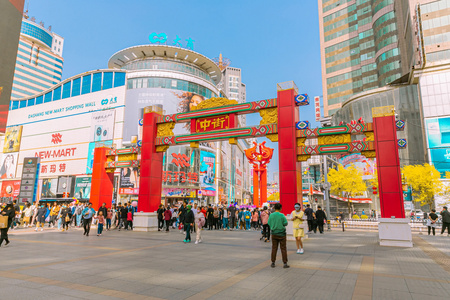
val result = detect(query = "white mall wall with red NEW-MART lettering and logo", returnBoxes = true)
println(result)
[8,86,126,177]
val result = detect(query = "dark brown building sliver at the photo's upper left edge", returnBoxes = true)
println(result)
[0,0,24,132]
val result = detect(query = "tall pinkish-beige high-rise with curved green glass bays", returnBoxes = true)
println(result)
[318,0,412,116]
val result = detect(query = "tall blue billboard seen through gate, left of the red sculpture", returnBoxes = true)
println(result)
[200,150,216,196]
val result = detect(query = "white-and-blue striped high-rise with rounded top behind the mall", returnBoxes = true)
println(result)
[11,15,64,100]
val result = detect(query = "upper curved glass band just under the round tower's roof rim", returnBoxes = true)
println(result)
[122,59,215,85]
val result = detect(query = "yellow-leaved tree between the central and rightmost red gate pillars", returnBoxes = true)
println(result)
[328,164,367,214]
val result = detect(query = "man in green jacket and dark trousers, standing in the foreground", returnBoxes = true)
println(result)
[268,203,289,269]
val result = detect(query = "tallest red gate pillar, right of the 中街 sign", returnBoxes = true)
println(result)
[277,89,303,214]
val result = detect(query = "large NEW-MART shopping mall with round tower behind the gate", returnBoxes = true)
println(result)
[0,44,251,203]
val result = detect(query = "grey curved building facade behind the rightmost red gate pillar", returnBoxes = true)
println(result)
[332,85,425,165]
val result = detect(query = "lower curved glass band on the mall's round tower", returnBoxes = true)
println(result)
[127,77,217,98]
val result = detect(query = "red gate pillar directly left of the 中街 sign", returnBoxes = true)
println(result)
[138,112,163,212]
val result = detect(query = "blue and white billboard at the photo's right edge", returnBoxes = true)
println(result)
[425,118,450,176]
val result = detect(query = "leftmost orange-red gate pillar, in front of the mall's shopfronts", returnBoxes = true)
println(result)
[90,147,114,210]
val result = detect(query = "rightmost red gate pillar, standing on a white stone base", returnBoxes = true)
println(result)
[373,116,405,218]
